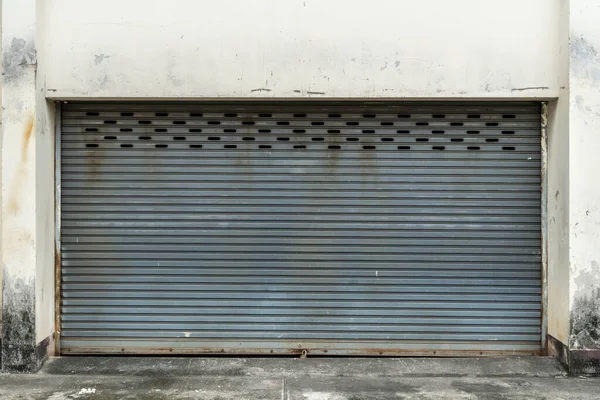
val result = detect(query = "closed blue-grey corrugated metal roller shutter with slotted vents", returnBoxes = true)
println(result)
[61,102,541,354]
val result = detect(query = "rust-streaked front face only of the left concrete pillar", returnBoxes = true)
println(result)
[1,0,36,369]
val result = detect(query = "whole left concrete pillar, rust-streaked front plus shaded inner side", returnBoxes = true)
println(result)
[0,0,54,371]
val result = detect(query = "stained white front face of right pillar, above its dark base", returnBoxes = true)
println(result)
[568,0,600,349]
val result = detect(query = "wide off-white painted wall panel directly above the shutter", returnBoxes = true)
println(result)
[44,0,559,99]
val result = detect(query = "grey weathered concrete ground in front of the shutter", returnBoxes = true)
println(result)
[0,357,600,400]
